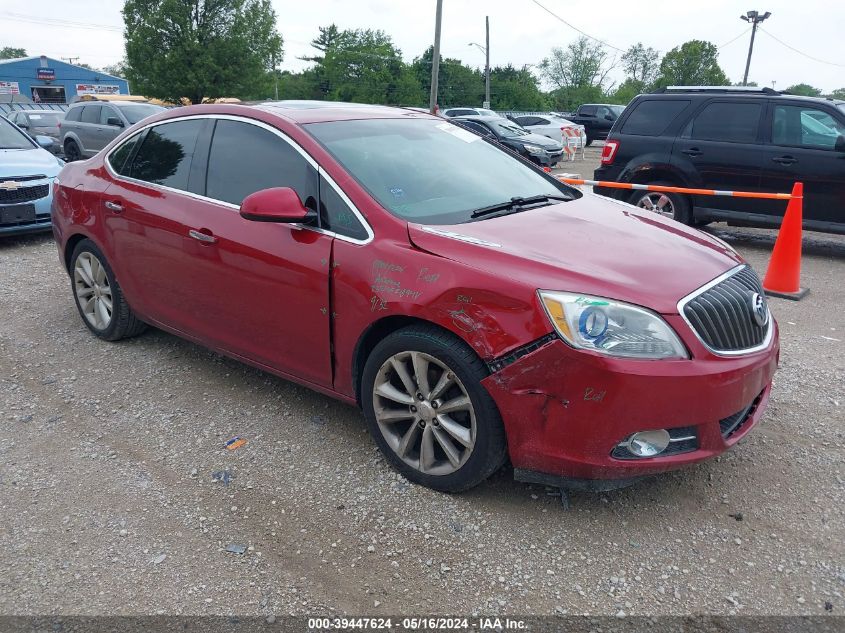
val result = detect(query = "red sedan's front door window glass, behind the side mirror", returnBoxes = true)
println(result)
[205,120,318,211]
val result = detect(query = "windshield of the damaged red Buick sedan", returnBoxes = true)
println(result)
[305,119,577,224]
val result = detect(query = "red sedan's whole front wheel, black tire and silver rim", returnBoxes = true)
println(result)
[361,326,507,492]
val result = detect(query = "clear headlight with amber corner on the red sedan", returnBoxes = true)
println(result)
[540,290,689,358]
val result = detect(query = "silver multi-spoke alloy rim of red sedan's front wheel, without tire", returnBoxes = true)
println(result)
[373,352,477,475]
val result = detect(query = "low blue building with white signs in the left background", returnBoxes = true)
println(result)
[0,55,129,103]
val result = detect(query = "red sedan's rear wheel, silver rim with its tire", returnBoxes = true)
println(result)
[70,240,146,341]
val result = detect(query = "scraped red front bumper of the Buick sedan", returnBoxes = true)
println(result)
[483,315,779,481]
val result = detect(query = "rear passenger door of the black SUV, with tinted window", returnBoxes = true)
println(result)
[672,99,766,218]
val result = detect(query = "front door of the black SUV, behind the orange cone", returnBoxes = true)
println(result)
[761,101,845,226]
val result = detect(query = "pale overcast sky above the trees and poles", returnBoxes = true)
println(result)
[0,0,845,92]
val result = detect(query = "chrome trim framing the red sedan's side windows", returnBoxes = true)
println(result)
[103,114,375,246]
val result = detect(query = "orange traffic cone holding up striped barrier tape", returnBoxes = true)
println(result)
[763,182,809,301]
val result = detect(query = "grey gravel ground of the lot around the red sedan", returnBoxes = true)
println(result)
[0,214,845,616]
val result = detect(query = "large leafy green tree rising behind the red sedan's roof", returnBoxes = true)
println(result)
[123,0,282,103]
